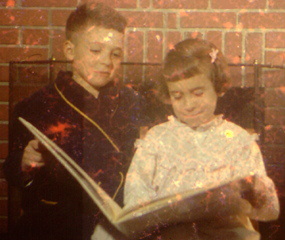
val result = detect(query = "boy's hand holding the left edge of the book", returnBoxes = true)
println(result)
[21,139,45,173]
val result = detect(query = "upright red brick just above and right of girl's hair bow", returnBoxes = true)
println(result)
[224,32,242,64]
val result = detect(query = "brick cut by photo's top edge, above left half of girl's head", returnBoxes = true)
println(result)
[153,0,208,9]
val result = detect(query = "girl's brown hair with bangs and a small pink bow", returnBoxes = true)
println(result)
[159,38,230,99]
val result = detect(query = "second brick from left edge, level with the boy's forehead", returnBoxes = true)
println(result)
[23,29,49,45]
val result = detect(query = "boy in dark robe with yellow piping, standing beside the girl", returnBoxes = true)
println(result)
[4,3,149,240]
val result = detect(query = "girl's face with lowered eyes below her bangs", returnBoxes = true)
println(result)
[167,74,218,129]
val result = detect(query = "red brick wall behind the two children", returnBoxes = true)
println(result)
[0,0,285,236]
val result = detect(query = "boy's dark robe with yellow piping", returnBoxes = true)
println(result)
[4,72,149,239]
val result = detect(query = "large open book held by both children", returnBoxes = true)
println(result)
[19,118,253,236]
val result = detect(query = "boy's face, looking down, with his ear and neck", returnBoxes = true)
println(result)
[65,26,124,93]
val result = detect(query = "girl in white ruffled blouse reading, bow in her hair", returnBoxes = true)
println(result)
[125,39,279,240]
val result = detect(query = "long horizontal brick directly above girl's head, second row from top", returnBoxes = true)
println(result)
[180,12,236,29]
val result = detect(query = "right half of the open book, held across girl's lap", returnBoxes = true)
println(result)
[113,175,251,235]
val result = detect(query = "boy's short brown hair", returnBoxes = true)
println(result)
[65,1,127,40]
